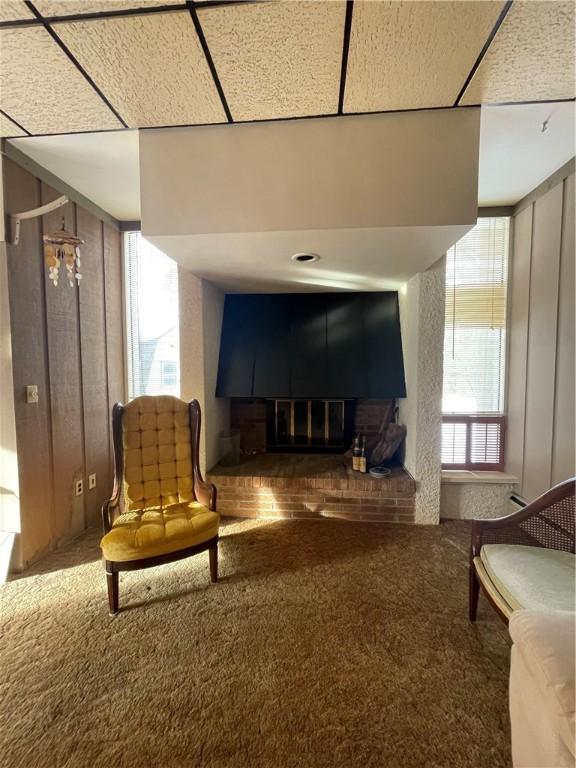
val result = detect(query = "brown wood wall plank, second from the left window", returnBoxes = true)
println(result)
[77,208,111,525]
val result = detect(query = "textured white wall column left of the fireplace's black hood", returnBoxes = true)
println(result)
[178,268,230,472]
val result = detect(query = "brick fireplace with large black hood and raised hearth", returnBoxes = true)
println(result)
[208,291,416,522]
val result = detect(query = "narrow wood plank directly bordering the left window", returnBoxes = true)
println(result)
[103,224,126,480]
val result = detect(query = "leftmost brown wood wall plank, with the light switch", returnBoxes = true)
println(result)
[2,160,53,566]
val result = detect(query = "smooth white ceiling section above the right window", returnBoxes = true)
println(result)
[478,103,575,205]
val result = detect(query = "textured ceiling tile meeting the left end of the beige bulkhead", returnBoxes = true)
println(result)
[54,11,226,128]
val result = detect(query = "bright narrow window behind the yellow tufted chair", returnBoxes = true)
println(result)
[124,232,180,398]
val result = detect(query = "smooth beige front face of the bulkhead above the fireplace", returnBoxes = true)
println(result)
[140,109,480,237]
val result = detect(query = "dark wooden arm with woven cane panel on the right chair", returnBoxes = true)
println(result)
[470,478,575,560]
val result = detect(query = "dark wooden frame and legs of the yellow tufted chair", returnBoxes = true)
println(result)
[102,400,218,615]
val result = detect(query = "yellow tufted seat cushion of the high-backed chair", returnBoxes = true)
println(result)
[100,502,220,562]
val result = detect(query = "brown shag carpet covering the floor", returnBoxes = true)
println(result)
[0,520,510,768]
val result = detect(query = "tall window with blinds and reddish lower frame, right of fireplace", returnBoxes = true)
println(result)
[442,218,509,469]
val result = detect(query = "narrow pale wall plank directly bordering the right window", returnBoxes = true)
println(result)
[506,206,532,483]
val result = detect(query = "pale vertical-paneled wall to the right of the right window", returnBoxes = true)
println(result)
[506,172,576,500]
